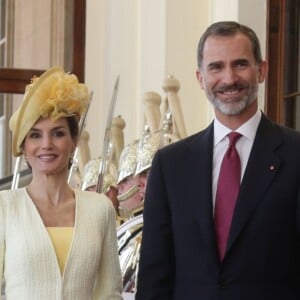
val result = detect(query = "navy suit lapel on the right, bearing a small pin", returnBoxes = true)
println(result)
[227,115,282,252]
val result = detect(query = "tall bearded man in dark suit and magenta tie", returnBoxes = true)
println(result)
[136,22,300,300]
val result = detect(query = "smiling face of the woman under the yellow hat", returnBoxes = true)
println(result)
[23,118,76,175]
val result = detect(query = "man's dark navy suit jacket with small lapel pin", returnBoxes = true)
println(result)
[136,115,300,300]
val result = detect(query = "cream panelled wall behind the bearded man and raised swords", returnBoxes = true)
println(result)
[86,0,266,157]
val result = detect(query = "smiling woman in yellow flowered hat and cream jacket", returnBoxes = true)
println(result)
[0,67,122,300]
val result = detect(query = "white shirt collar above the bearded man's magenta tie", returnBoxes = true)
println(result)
[214,110,261,145]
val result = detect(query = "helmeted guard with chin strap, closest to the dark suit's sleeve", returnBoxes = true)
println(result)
[117,140,143,293]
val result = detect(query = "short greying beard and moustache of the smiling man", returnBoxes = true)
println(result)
[205,85,258,116]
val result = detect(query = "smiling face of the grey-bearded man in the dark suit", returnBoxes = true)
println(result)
[197,33,267,115]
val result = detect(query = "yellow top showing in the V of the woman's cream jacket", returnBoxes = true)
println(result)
[47,227,74,274]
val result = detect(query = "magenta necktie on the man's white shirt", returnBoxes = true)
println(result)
[215,132,241,261]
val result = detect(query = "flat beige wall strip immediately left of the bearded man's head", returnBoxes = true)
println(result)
[165,0,210,134]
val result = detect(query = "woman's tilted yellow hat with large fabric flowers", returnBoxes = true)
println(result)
[9,67,89,156]
